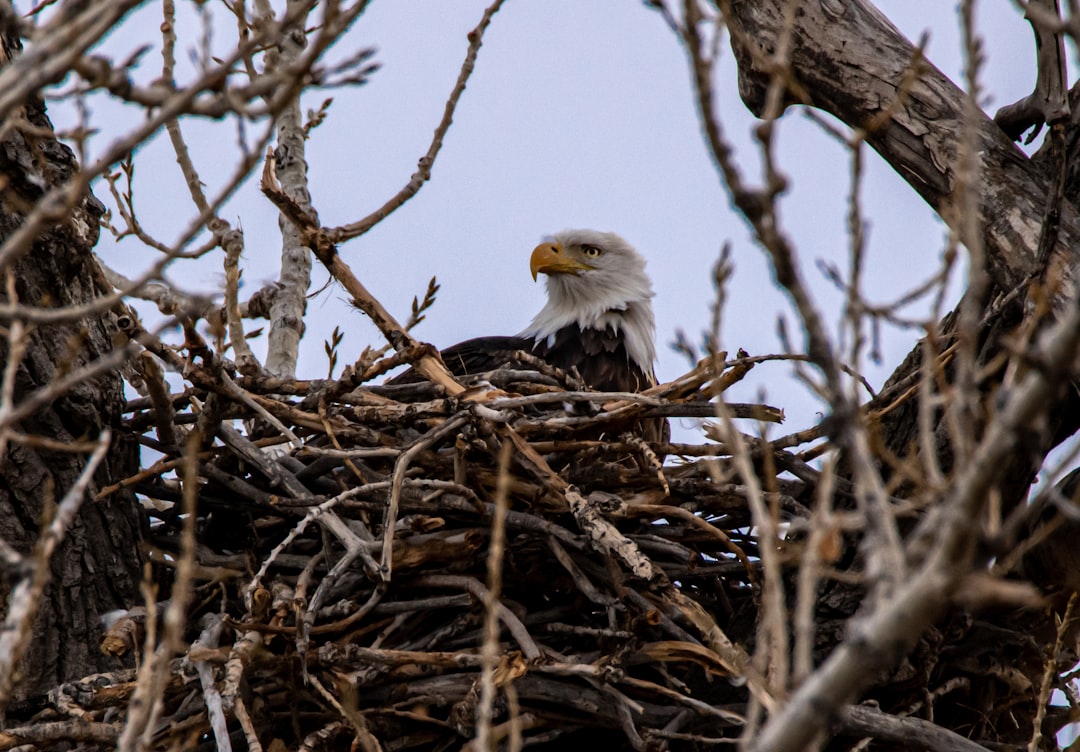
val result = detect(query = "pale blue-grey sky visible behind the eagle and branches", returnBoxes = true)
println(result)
[39,0,1035,438]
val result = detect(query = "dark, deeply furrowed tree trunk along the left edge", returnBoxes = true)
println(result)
[0,17,141,700]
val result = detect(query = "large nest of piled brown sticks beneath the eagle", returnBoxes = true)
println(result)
[12,337,1071,750]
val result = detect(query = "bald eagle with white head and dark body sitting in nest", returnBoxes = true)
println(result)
[391,230,667,441]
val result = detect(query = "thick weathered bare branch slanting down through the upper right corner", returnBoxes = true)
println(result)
[729,0,1080,309]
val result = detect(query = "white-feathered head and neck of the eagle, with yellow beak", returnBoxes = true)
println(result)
[522,230,657,374]
